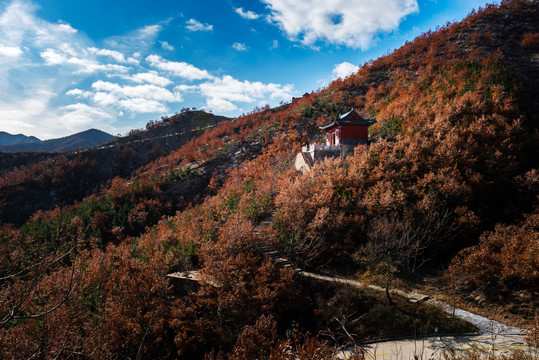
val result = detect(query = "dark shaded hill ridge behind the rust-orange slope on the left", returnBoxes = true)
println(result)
[0,110,228,225]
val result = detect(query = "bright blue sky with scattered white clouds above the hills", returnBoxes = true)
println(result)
[0,0,498,140]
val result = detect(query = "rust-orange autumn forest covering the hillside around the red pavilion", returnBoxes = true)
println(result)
[0,0,539,359]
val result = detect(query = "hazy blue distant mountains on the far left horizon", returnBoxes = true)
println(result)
[0,129,114,152]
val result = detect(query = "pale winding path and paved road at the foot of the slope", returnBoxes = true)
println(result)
[171,212,539,360]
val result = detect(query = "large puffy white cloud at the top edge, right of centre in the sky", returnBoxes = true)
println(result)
[262,0,419,49]
